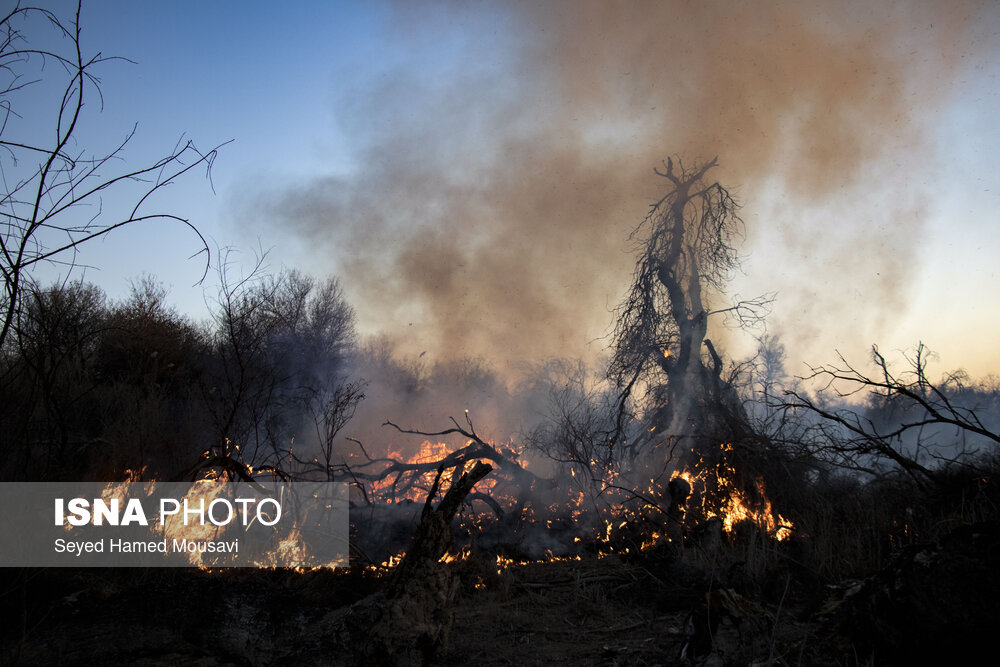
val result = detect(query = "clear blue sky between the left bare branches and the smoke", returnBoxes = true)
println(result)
[49,2,384,290]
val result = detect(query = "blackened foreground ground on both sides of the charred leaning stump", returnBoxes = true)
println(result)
[0,524,1000,667]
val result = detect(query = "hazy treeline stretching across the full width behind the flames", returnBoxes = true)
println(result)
[0,271,1000,578]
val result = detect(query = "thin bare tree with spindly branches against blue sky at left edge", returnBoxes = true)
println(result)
[0,3,218,345]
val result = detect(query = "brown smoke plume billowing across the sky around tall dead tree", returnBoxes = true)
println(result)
[254,1,988,372]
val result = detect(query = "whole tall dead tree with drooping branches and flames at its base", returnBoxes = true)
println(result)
[596,158,783,548]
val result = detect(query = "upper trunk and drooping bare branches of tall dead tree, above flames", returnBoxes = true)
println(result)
[609,158,773,456]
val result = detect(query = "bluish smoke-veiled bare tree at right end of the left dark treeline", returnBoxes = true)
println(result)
[203,254,363,473]
